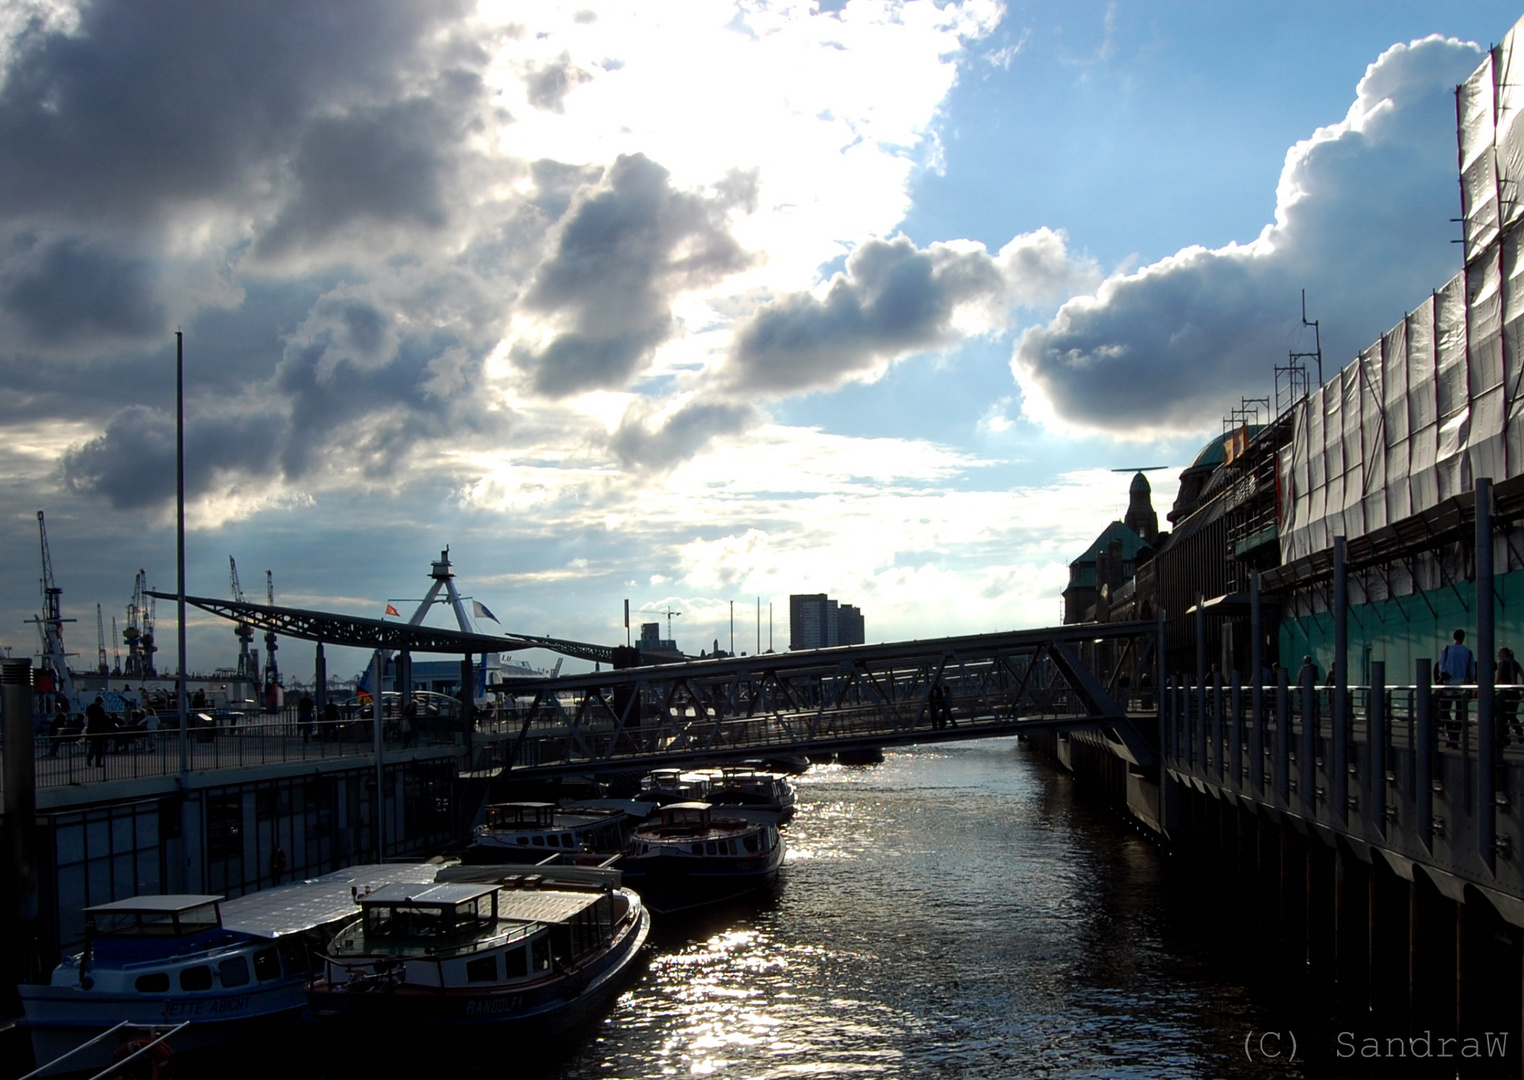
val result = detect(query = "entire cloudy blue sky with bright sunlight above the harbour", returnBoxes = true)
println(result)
[0,0,1524,679]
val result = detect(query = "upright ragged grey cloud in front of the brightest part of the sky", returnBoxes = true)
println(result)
[512,154,756,398]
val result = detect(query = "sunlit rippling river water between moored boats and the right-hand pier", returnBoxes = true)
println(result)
[518,739,1303,1080]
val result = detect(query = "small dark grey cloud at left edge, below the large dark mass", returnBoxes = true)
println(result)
[0,236,165,346]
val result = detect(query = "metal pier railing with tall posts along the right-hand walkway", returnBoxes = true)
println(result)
[1160,663,1524,897]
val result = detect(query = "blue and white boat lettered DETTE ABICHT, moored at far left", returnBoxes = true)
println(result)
[17,862,439,1071]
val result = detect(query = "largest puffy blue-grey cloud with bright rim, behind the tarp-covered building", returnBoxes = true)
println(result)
[1012,38,1478,433]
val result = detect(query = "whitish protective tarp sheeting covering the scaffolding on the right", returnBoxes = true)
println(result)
[1280,21,1524,562]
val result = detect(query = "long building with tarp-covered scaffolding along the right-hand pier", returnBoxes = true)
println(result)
[1097,23,1524,679]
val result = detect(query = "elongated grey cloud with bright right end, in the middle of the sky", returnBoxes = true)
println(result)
[730,236,1007,393]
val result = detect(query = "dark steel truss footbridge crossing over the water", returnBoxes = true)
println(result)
[484,621,1158,777]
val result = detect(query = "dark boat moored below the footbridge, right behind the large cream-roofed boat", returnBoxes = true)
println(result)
[620,803,783,915]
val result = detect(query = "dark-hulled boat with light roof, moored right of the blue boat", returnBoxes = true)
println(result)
[306,865,651,1035]
